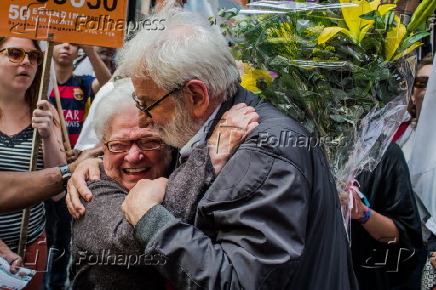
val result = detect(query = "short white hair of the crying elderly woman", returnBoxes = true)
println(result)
[94,78,135,141]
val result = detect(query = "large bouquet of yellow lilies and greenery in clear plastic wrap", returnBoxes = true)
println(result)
[210,0,436,224]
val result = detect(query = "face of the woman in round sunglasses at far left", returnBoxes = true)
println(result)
[0,37,38,93]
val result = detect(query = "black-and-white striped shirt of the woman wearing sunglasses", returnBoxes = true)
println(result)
[0,126,45,251]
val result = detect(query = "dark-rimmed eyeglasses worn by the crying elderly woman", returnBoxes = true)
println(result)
[105,137,163,153]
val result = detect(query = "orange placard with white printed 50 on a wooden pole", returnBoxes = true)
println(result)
[0,0,127,47]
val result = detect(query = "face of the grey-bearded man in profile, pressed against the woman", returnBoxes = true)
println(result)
[132,78,202,148]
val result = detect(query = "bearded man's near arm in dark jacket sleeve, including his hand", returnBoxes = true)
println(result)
[122,147,310,289]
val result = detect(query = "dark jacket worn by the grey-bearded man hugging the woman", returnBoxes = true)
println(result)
[135,88,357,290]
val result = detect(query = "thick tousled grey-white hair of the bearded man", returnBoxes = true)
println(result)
[118,1,240,103]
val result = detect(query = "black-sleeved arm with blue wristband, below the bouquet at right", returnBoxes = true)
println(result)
[352,142,422,249]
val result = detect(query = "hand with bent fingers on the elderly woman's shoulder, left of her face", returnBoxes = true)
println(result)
[66,158,102,219]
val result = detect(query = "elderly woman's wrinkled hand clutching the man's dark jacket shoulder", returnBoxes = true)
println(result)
[208,103,259,175]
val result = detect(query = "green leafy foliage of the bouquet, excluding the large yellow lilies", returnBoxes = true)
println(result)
[215,1,425,176]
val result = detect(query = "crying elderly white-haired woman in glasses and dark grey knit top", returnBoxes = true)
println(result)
[72,79,255,289]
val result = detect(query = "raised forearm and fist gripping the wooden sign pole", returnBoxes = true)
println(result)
[32,101,66,168]
